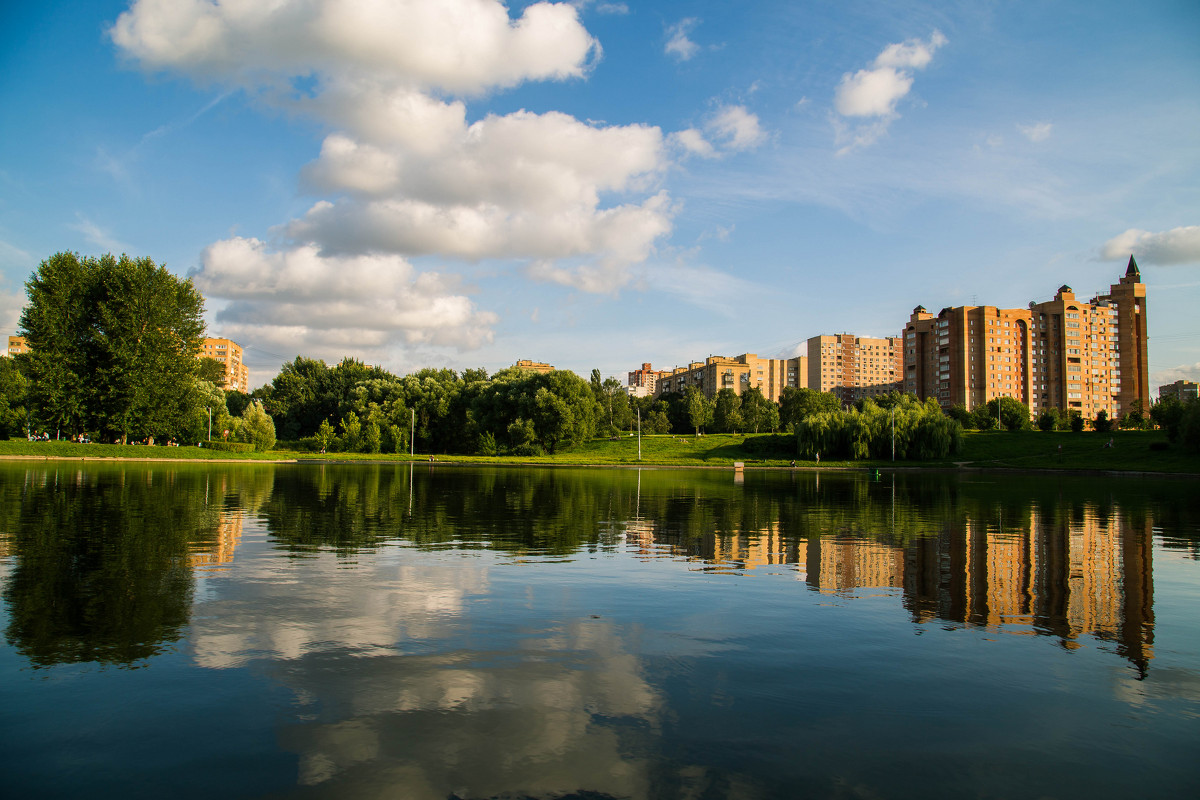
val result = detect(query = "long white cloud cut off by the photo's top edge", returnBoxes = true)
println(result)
[110,0,598,94]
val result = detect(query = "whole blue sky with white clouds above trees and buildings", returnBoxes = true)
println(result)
[0,0,1200,386]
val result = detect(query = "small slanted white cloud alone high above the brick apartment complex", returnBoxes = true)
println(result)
[834,30,947,152]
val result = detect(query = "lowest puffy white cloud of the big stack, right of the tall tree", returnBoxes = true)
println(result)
[192,236,497,354]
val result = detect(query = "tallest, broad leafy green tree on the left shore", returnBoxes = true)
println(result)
[20,253,204,441]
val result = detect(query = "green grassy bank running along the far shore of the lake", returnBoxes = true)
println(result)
[0,431,1200,474]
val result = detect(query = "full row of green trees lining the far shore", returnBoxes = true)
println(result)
[0,253,1200,458]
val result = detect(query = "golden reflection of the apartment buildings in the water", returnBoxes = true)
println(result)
[625,504,1154,676]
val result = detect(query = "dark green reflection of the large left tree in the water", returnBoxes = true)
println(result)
[0,467,269,667]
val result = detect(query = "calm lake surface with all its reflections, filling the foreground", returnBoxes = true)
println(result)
[0,462,1200,800]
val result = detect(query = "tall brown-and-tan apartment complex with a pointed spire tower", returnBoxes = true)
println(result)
[904,257,1150,419]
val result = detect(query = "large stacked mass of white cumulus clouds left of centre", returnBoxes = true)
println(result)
[110,0,681,357]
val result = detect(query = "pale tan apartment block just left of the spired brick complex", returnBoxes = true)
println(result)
[808,333,904,403]
